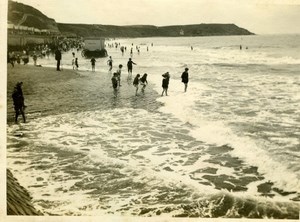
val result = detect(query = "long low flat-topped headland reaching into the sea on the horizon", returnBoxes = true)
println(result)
[57,23,253,37]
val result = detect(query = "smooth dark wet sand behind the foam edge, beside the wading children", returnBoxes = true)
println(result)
[7,65,159,124]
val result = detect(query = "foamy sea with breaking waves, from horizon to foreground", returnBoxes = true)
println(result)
[7,34,300,219]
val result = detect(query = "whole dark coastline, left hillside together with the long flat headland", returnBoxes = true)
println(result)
[8,0,253,38]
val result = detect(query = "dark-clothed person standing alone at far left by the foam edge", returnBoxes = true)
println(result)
[12,82,26,123]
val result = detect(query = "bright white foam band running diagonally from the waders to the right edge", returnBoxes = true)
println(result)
[154,76,300,193]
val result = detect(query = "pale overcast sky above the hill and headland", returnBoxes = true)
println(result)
[6,0,300,34]
